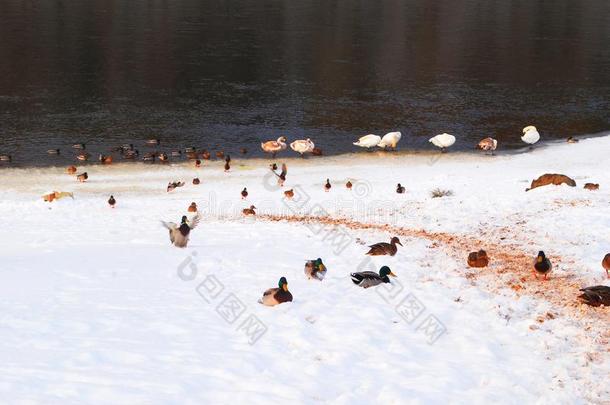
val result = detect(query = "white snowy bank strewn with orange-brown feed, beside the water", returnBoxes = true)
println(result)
[0,136,610,404]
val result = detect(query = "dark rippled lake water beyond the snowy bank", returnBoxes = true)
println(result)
[0,0,610,165]
